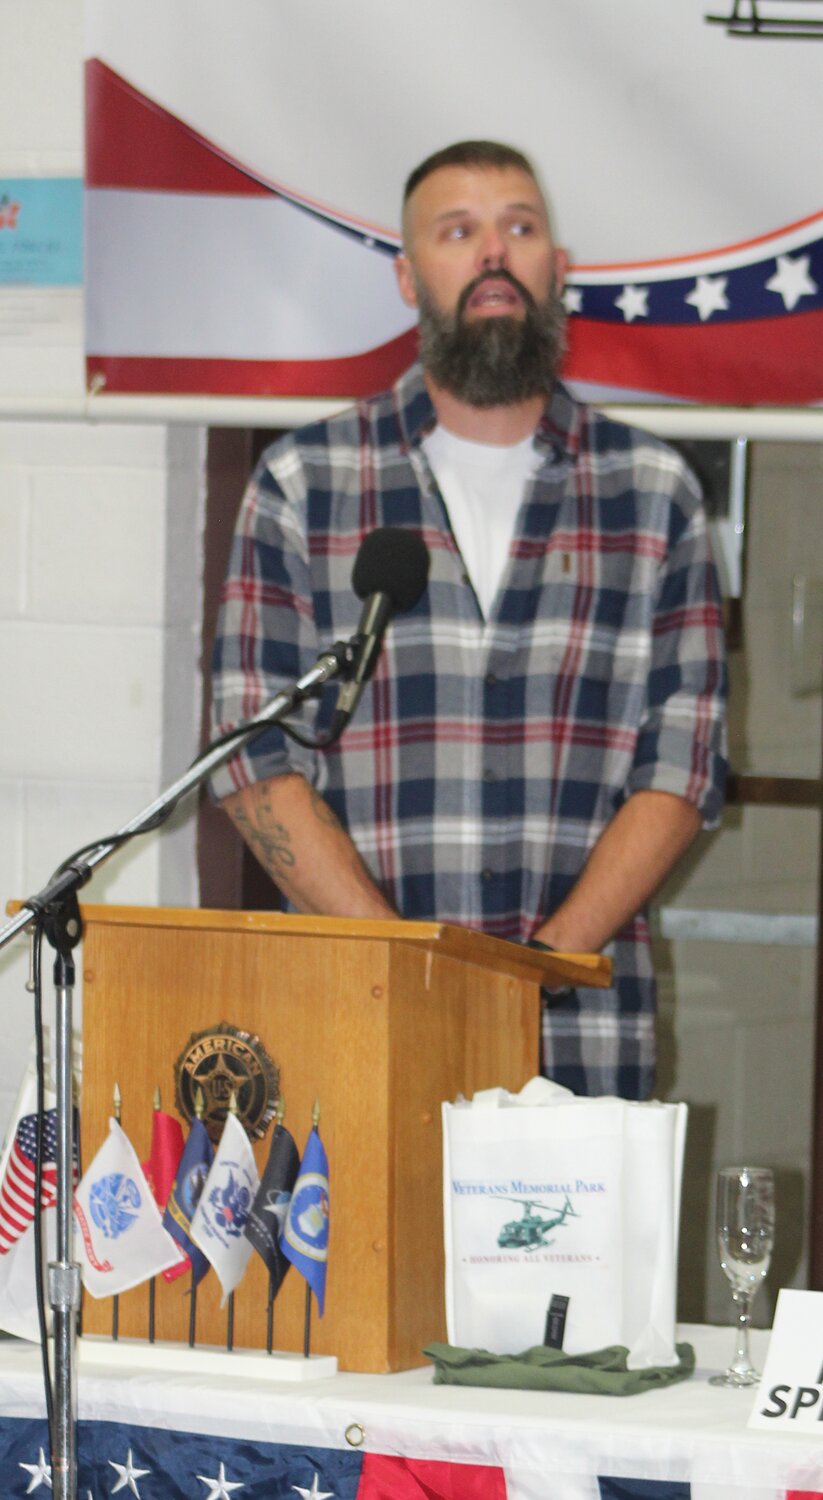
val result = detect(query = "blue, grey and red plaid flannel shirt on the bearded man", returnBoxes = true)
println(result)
[214,357,726,1098]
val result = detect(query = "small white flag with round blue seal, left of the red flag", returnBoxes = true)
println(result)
[75,1119,178,1298]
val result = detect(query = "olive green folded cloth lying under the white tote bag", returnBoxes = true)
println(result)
[423,1344,694,1397]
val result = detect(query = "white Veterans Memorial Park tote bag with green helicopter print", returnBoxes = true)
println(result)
[442,1079,687,1370]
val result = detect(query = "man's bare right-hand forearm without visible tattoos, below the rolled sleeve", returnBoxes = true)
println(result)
[534,792,702,953]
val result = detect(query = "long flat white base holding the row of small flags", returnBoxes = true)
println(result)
[76,1334,337,1383]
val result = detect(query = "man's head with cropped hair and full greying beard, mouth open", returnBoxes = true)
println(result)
[397,167,565,407]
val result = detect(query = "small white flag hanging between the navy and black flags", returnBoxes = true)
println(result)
[189,1115,259,1302]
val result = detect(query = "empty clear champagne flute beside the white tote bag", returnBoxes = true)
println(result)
[709,1167,775,1386]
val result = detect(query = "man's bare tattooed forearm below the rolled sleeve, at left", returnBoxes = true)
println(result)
[222,773,397,917]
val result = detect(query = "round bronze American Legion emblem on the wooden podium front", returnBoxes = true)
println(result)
[174,1022,280,1143]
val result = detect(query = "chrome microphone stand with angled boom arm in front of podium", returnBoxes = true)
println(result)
[0,635,363,1500]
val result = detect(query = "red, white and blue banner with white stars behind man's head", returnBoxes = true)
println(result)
[81,0,823,405]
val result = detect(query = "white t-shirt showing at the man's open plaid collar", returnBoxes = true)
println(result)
[423,426,540,618]
